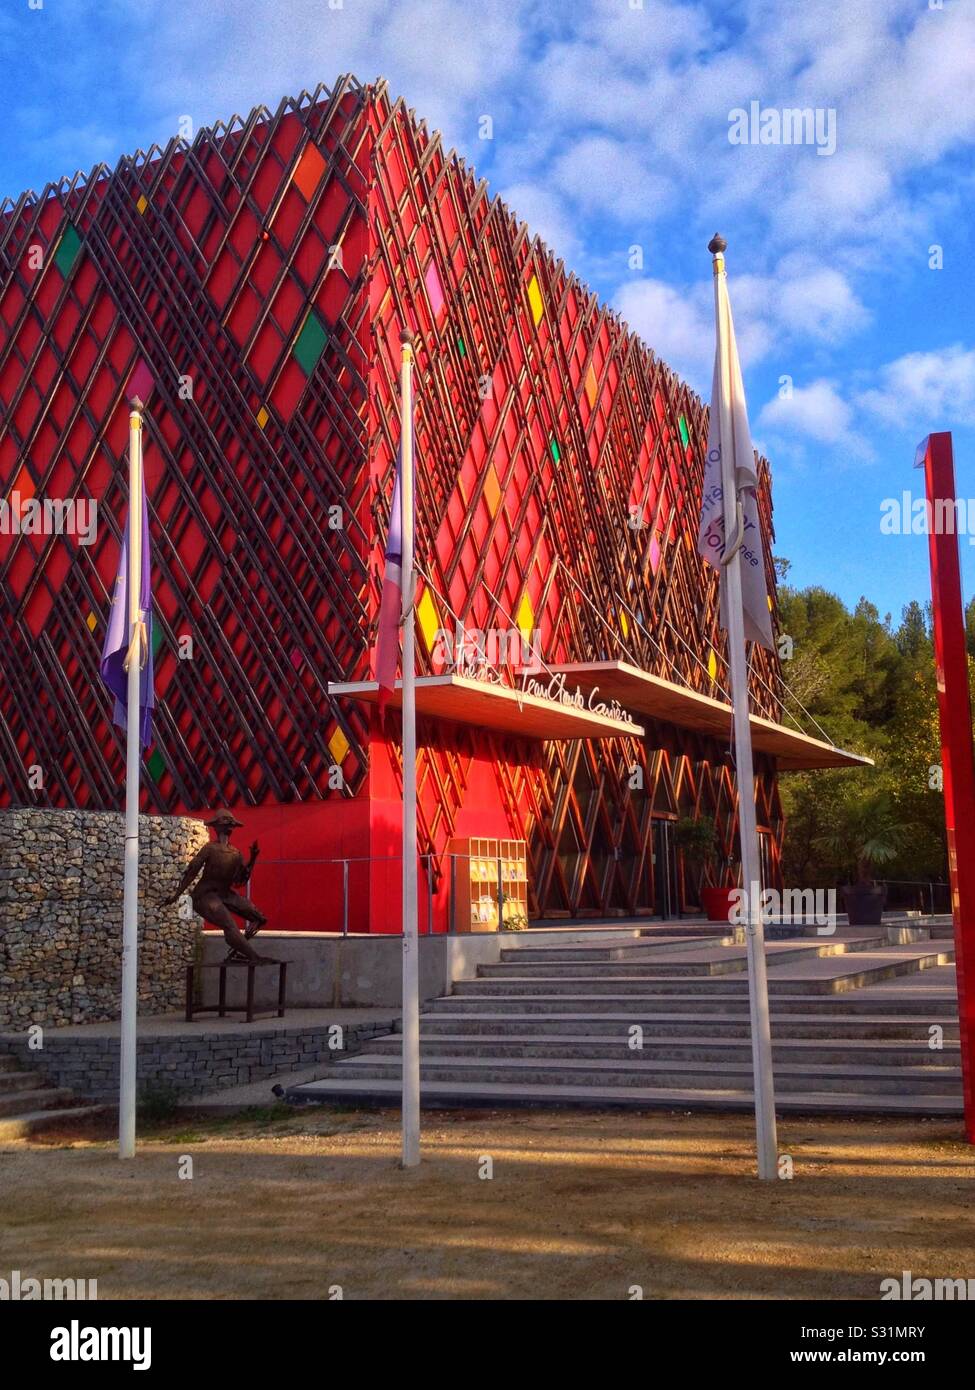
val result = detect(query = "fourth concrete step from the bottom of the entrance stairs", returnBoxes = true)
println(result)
[424,981,958,1023]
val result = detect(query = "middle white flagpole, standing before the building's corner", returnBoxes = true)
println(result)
[399,329,420,1168]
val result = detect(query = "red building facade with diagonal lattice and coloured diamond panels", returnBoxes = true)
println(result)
[0,79,816,930]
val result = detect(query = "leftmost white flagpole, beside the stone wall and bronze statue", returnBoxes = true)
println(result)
[118,400,142,1158]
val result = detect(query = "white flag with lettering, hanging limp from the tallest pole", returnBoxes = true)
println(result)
[697,286,773,649]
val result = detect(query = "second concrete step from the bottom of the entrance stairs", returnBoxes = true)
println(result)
[326,1052,961,1095]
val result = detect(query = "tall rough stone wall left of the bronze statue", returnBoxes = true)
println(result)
[0,806,209,1029]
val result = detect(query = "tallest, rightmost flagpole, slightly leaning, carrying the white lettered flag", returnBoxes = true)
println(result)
[708,235,779,1180]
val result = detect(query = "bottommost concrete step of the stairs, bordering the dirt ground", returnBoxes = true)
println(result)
[285,1074,964,1116]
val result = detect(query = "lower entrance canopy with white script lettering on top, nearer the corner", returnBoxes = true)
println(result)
[328,674,644,739]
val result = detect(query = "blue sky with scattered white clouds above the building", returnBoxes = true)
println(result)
[0,0,975,617]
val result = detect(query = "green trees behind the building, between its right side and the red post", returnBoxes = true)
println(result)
[779,587,975,887]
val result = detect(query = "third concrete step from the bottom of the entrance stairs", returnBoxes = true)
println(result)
[369,1026,961,1068]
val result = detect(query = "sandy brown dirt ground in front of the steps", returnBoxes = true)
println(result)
[0,1106,975,1300]
